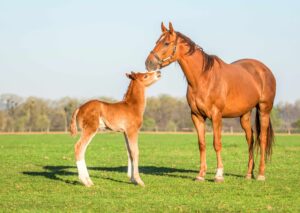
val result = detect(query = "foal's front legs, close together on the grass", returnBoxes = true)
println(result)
[125,131,145,186]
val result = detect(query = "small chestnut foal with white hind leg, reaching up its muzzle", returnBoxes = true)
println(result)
[70,71,160,187]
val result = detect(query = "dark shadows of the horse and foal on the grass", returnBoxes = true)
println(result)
[22,166,244,185]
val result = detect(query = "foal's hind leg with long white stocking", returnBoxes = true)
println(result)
[75,130,96,187]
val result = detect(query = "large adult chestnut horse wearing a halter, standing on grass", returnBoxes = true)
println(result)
[145,23,276,181]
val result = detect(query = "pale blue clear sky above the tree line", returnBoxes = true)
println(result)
[0,0,300,103]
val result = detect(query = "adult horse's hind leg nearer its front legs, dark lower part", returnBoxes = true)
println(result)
[240,111,254,179]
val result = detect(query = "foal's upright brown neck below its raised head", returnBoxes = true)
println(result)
[124,80,145,112]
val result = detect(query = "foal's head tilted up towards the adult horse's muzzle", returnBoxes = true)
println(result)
[126,71,161,87]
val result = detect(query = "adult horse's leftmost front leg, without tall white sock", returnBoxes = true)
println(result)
[192,113,207,181]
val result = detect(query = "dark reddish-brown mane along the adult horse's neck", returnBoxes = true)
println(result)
[176,32,221,71]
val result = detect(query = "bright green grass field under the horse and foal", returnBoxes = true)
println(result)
[0,133,300,212]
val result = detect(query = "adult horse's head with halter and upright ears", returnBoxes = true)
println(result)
[145,22,178,71]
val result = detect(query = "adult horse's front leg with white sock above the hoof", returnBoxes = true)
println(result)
[212,112,224,182]
